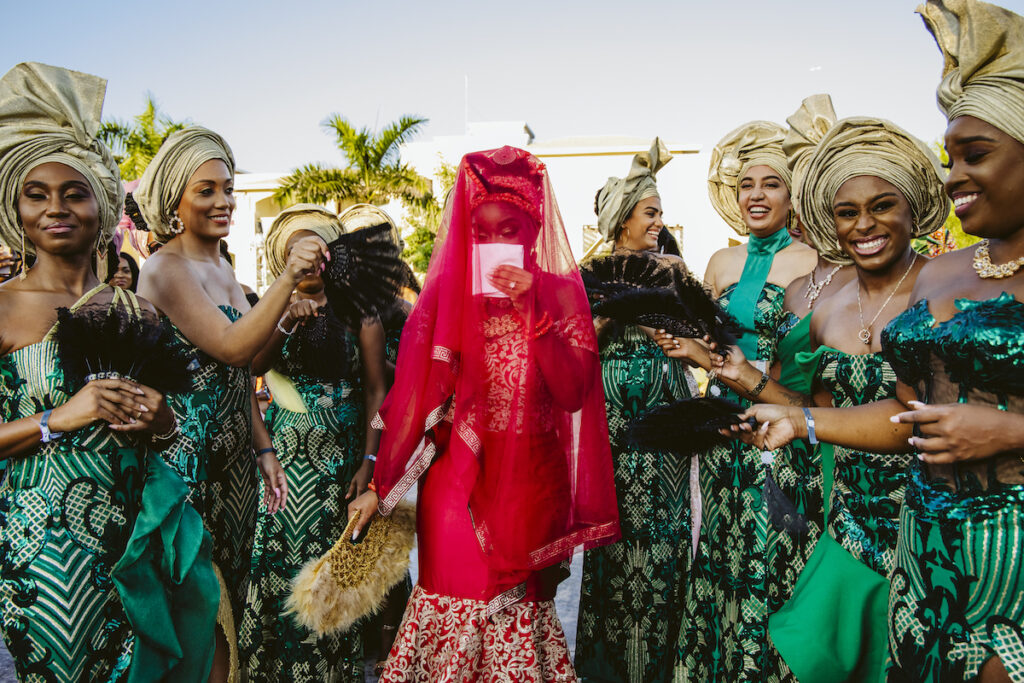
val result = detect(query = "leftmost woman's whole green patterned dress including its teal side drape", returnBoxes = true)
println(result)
[0,285,217,681]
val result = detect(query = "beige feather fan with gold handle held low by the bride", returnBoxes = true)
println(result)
[285,503,416,635]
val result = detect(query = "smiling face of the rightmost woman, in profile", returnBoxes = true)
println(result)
[945,116,1024,240]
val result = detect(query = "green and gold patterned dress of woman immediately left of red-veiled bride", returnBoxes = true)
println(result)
[239,308,366,682]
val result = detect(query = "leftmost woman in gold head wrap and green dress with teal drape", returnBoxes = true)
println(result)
[0,63,217,681]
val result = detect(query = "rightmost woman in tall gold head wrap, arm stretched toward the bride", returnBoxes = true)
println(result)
[751,1,1024,683]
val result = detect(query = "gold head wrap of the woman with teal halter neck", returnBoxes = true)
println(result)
[708,121,793,234]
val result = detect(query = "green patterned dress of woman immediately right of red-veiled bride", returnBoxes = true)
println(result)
[575,326,696,683]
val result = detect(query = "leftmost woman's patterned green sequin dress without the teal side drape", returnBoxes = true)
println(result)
[0,340,140,681]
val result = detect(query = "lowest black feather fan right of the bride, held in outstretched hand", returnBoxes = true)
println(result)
[629,397,743,455]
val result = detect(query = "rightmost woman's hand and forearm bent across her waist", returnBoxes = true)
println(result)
[891,400,1024,465]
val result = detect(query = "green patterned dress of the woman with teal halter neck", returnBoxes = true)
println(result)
[674,284,796,682]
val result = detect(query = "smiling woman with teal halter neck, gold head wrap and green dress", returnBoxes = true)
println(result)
[673,121,817,681]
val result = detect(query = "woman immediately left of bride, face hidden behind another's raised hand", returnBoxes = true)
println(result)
[239,204,386,683]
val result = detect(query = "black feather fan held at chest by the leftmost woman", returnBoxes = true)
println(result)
[54,303,194,393]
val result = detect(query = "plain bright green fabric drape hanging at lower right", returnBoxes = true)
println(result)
[768,444,889,683]
